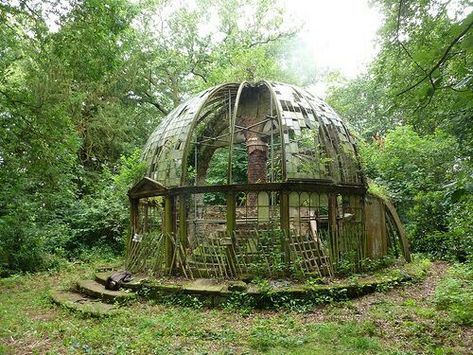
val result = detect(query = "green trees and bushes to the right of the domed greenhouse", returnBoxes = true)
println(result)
[328,0,473,262]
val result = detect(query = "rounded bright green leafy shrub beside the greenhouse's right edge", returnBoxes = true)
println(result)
[360,126,473,262]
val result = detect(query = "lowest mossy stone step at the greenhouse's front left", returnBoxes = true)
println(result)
[50,290,116,317]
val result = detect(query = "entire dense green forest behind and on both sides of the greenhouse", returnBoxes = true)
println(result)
[0,0,473,274]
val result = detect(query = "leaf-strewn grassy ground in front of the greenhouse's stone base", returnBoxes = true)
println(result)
[0,263,473,354]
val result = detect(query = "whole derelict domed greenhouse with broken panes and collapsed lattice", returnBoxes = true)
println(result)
[126,81,409,279]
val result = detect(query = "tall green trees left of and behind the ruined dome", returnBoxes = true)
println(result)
[0,0,303,274]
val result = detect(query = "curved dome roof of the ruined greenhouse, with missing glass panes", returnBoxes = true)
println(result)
[143,81,363,187]
